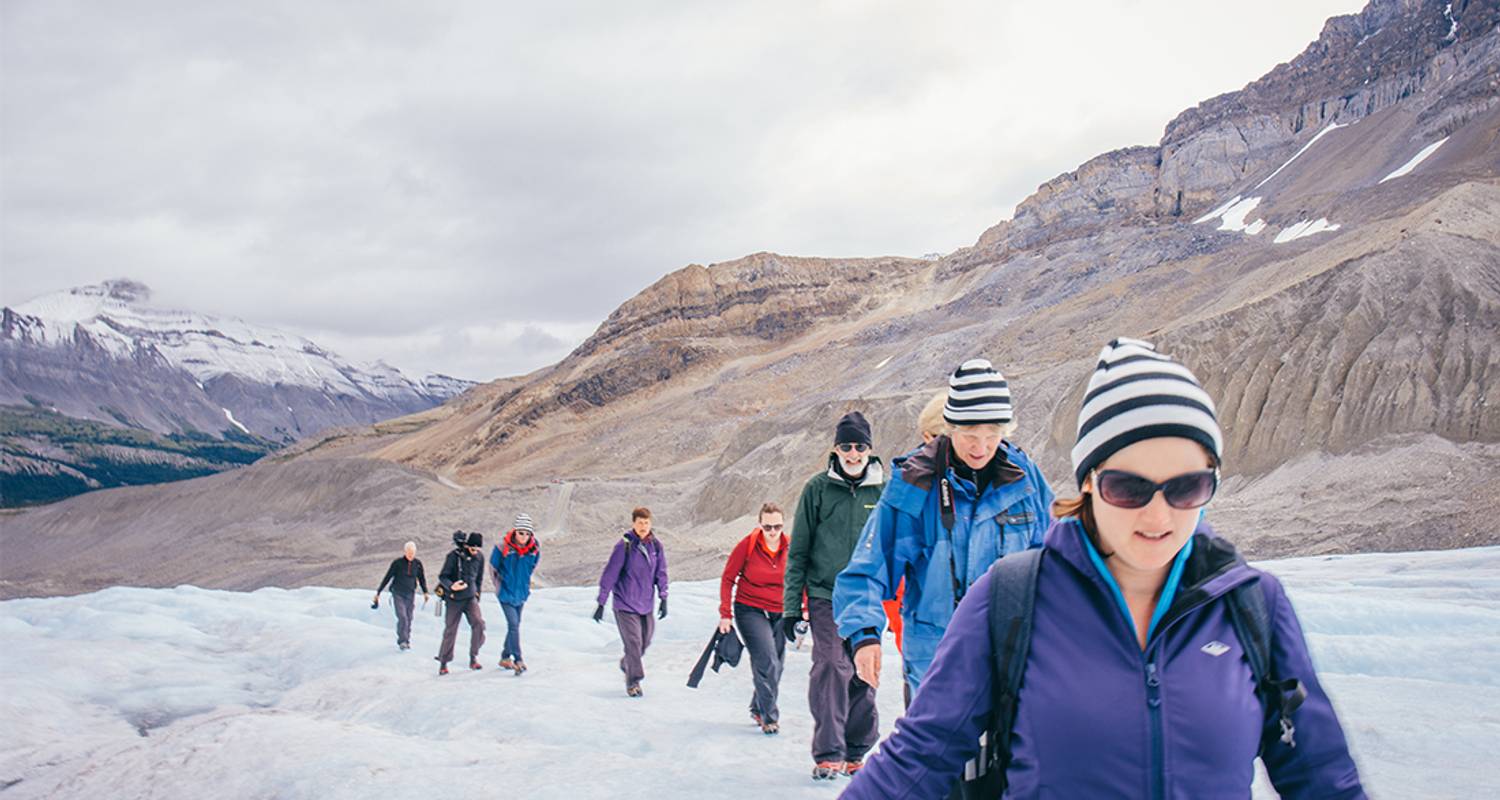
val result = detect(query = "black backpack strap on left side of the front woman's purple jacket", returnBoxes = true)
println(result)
[965,549,1044,797]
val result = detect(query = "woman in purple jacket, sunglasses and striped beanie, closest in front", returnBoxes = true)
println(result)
[845,339,1365,798]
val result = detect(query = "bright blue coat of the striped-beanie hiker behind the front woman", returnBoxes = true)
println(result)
[834,437,1053,690]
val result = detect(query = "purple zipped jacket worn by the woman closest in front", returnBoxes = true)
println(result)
[845,518,1365,798]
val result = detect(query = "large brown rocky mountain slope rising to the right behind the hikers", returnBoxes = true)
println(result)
[0,0,1500,594]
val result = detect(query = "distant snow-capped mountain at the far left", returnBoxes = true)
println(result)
[0,279,474,443]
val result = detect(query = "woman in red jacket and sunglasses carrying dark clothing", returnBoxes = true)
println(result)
[719,503,789,735]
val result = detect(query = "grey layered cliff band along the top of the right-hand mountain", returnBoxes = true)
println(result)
[977,0,1500,249]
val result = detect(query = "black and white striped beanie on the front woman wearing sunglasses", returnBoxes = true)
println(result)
[1073,338,1224,486]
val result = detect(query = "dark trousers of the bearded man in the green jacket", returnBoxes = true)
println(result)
[807,597,881,761]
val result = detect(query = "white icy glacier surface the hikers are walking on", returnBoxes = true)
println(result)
[0,548,1500,800]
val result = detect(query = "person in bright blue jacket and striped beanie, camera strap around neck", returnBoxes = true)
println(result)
[834,359,1053,695]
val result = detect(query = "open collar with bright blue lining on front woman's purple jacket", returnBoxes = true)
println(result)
[1046,516,1256,639]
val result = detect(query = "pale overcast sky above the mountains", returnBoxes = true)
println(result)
[0,0,1362,380]
